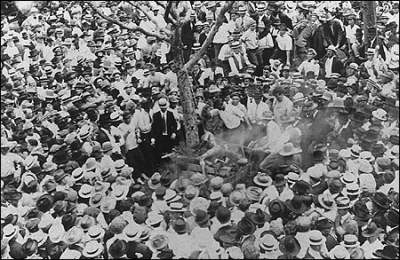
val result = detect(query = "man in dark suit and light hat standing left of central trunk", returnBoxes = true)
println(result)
[151,98,177,162]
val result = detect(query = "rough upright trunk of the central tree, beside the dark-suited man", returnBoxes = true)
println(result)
[171,24,199,148]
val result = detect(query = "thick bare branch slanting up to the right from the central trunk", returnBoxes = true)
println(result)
[183,1,234,71]
